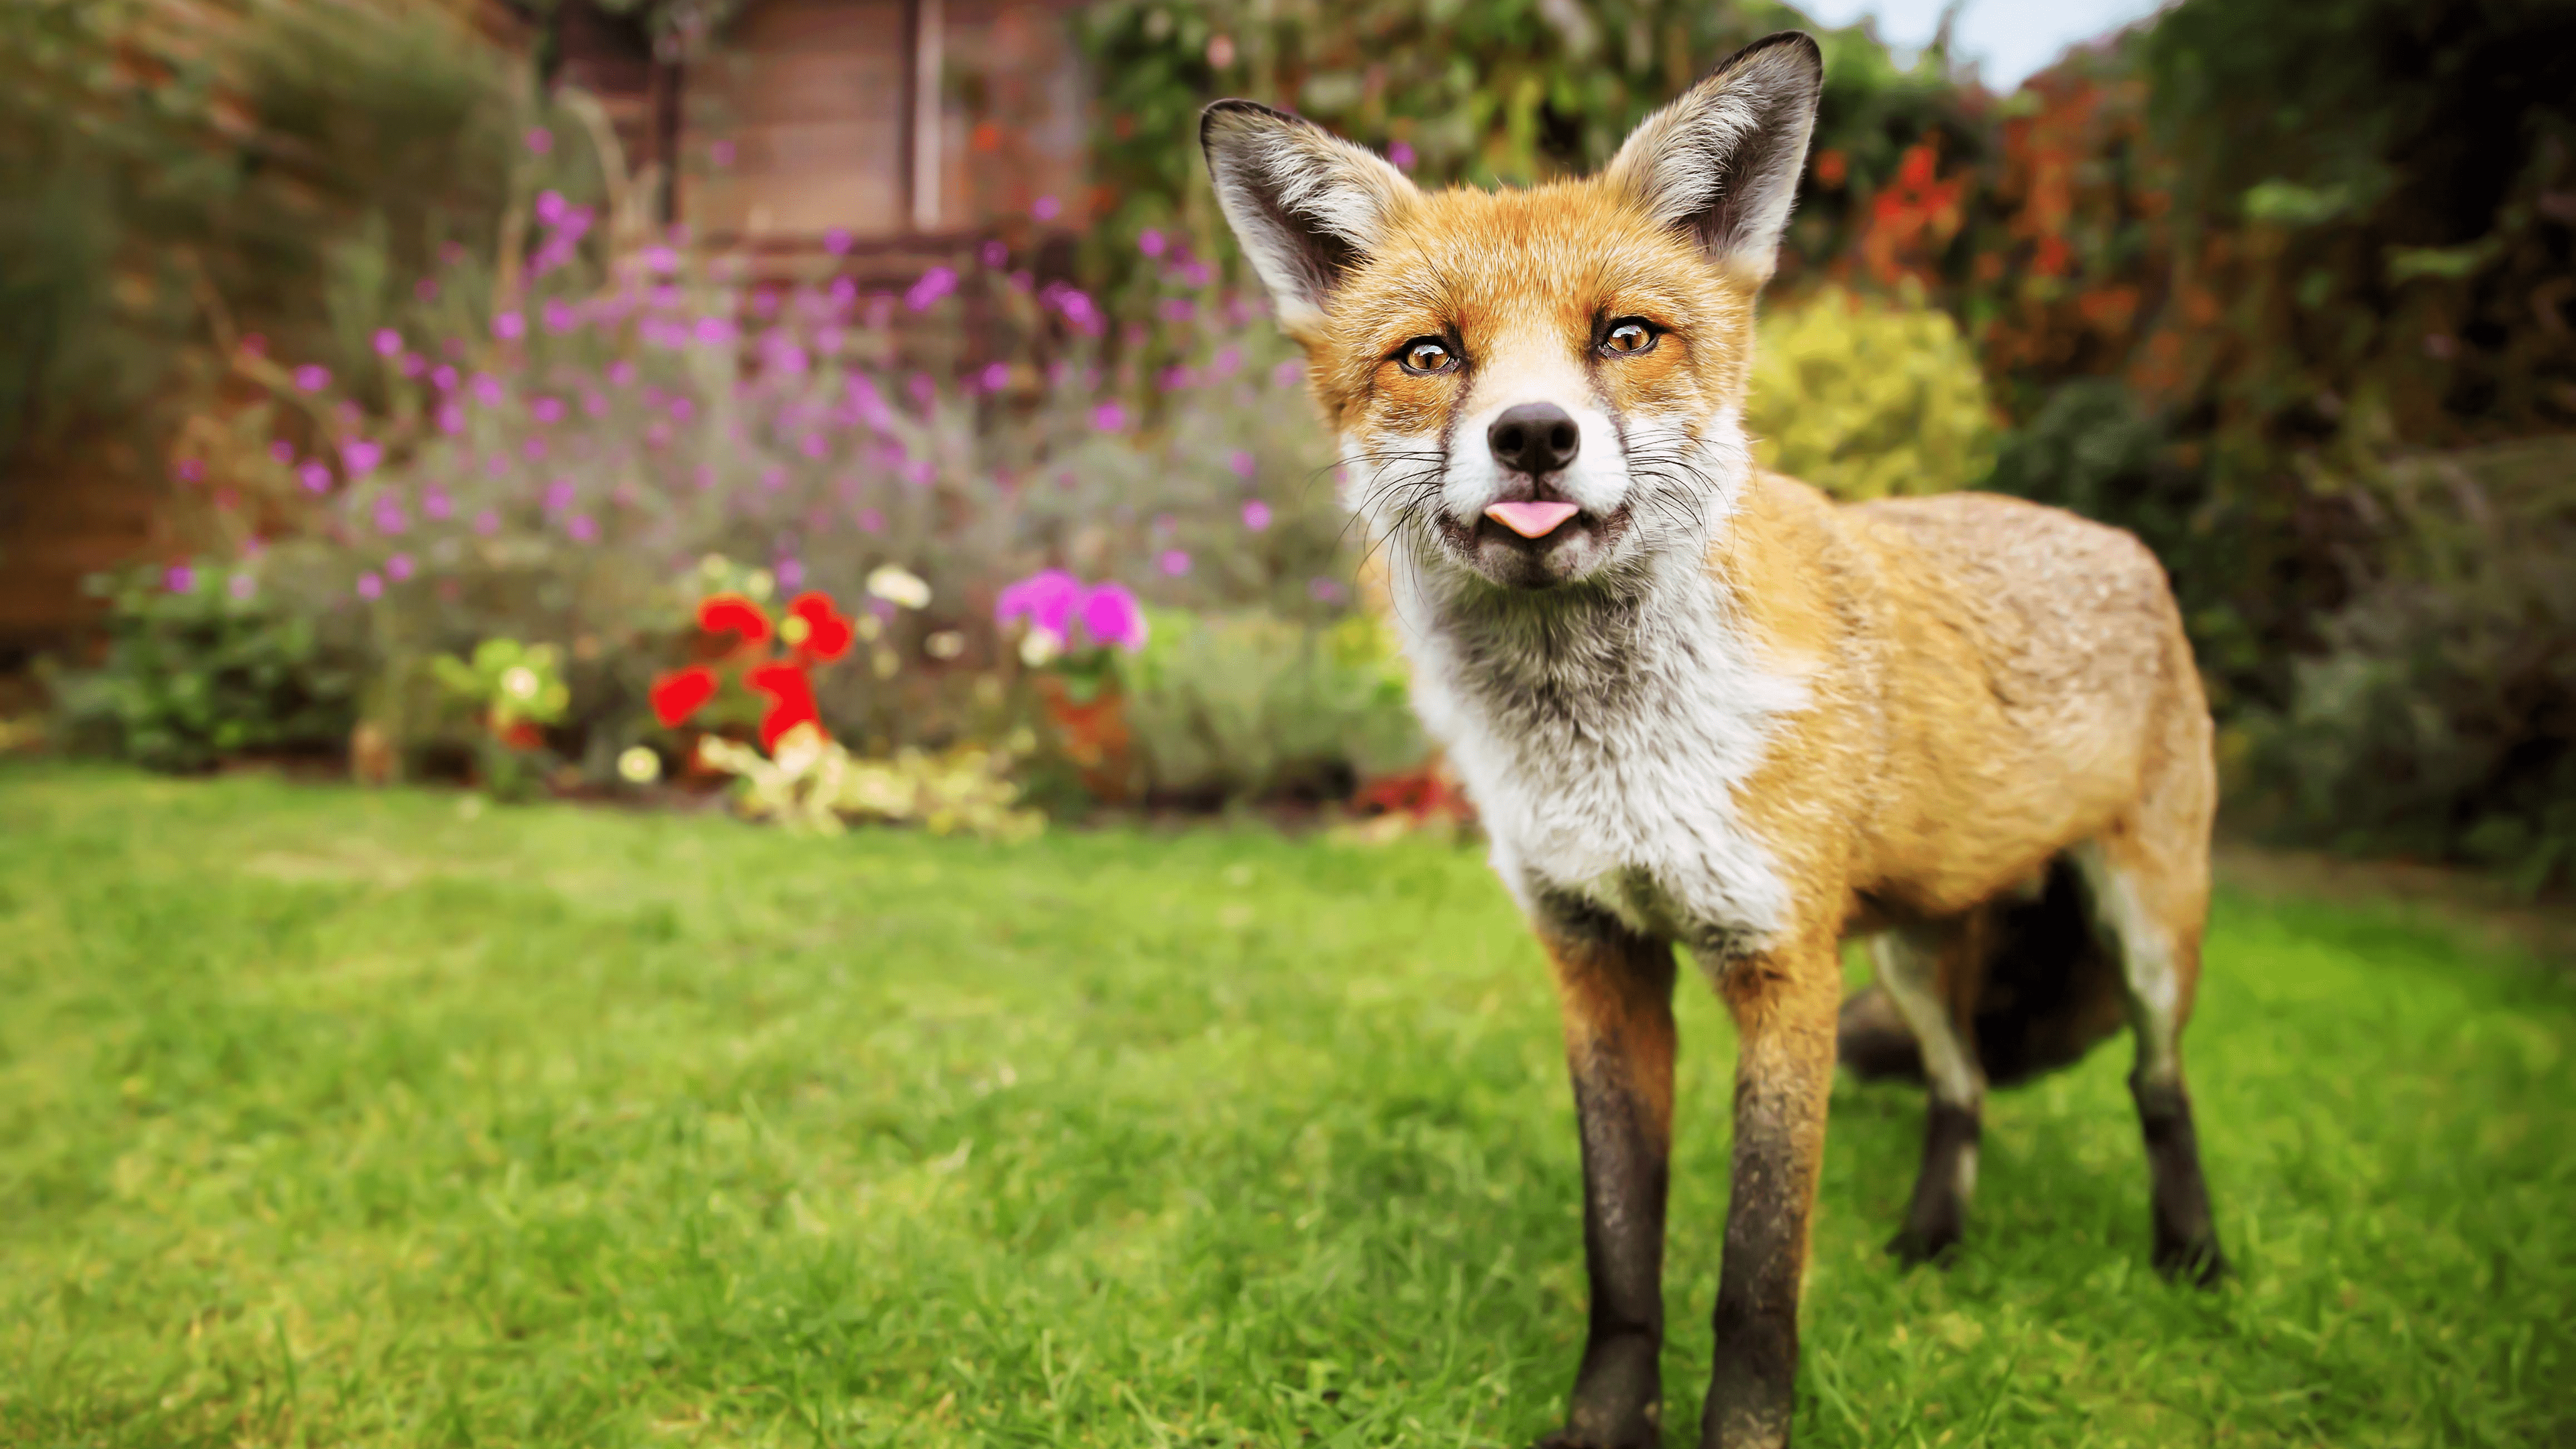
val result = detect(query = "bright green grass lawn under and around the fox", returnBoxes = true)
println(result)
[0,768,2576,1446]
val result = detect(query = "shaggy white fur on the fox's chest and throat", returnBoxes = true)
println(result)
[1396,551,1806,949]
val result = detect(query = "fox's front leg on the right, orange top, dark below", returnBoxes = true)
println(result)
[1700,936,1842,1449]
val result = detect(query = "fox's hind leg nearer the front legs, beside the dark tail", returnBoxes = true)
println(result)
[1870,918,1986,1263]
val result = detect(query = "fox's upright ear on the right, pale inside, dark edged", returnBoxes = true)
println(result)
[1607,31,1824,286]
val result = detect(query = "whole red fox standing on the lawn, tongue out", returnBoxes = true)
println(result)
[1200,31,2220,1449]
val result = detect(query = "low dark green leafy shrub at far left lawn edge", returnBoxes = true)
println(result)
[54,568,358,771]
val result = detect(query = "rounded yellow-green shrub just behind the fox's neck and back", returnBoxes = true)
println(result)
[1744,286,1994,500]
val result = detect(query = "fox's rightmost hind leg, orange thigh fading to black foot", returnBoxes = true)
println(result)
[2069,830,2226,1284]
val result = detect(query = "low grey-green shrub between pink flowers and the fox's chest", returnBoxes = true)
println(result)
[1120,608,1425,802]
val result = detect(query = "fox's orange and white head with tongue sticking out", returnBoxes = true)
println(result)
[1200,31,1824,590]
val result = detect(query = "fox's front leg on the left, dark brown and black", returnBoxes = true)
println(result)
[1538,905,1674,1449]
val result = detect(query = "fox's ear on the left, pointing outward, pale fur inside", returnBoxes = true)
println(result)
[1198,101,1417,330]
